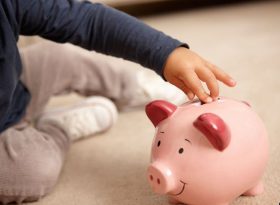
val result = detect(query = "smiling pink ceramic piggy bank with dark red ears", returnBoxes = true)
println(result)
[146,98,268,205]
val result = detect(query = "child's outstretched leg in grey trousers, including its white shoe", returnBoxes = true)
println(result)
[21,42,185,118]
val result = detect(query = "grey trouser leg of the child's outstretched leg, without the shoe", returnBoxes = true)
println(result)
[20,42,135,117]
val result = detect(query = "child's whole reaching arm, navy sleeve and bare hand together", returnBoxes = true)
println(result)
[16,0,235,101]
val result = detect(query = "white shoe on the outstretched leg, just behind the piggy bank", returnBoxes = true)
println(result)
[120,69,187,110]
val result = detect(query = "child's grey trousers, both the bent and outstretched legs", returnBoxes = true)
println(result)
[0,42,141,203]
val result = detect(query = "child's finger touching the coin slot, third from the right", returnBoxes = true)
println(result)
[181,71,212,102]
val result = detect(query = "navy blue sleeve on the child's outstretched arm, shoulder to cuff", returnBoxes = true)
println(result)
[14,0,188,74]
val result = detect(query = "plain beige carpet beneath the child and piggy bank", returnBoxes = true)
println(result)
[25,1,280,205]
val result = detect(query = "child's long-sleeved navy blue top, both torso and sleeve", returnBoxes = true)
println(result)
[0,0,187,132]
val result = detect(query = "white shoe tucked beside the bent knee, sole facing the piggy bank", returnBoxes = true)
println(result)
[37,96,118,141]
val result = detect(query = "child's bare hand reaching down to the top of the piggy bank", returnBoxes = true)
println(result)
[163,47,236,102]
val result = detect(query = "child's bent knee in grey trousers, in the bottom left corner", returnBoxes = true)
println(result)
[0,128,62,204]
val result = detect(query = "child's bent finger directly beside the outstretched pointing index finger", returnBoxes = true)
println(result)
[197,68,219,98]
